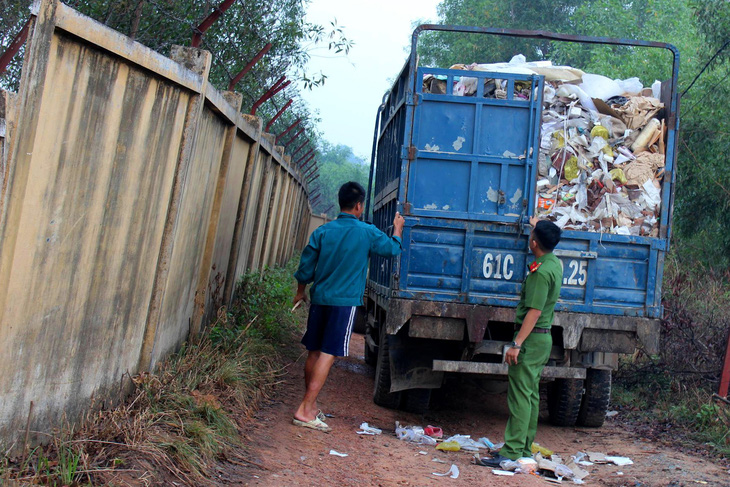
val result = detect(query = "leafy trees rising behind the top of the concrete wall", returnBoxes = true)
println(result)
[0,0,353,167]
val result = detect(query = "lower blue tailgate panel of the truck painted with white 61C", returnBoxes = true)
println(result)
[397,218,660,317]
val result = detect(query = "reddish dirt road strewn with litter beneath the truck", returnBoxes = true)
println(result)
[223,335,730,487]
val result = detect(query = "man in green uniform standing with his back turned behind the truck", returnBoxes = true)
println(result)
[481,217,563,468]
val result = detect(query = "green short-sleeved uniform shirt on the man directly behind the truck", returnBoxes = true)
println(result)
[515,252,563,328]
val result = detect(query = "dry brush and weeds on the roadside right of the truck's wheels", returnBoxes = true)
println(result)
[612,254,730,459]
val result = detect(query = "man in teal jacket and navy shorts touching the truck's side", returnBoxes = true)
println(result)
[294,182,405,431]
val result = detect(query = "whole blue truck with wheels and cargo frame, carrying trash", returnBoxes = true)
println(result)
[361,25,679,426]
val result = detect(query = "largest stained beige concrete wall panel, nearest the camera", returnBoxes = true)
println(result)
[0,30,189,442]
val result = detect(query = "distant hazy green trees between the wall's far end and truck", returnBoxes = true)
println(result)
[312,141,370,218]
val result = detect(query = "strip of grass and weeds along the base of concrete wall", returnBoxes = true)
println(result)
[0,259,301,486]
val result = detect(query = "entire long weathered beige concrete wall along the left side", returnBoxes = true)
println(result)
[0,0,309,450]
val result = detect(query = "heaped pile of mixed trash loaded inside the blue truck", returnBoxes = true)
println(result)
[423,55,667,237]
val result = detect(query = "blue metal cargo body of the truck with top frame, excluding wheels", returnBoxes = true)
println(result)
[368,26,679,324]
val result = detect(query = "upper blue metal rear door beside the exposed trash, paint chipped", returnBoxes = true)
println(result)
[406,68,543,223]
